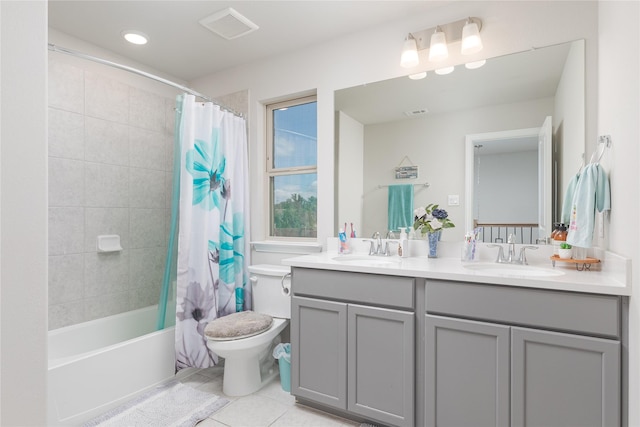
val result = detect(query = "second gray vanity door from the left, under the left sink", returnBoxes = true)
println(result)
[347,304,415,426]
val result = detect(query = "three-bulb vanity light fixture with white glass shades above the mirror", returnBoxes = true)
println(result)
[400,17,482,68]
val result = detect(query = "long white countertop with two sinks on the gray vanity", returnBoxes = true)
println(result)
[282,242,631,295]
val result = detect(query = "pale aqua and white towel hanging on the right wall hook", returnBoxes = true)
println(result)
[567,163,611,248]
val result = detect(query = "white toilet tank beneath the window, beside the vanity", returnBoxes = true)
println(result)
[249,264,291,319]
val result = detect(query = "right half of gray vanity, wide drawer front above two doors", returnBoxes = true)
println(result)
[424,281,621,427]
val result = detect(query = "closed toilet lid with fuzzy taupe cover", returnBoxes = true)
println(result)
[204,311,273,340]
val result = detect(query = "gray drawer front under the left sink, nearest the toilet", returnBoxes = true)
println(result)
[291,267,415,309]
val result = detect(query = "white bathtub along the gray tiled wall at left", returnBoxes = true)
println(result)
[47,306,175,425]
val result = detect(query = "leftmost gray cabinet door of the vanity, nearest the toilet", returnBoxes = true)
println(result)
[291,297,347,409]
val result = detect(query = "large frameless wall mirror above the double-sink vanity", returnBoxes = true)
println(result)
[335,40,585,243]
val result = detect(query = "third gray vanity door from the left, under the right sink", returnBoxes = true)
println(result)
[425,315,509,427]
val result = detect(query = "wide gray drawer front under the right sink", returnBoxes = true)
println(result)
[426,280,620,338]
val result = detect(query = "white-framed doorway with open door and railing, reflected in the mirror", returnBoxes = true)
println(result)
[465,116,553,244]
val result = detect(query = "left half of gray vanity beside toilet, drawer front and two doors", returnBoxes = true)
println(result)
[291,268,415,427]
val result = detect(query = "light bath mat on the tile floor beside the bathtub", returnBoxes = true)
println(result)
[84,381,229,427]
